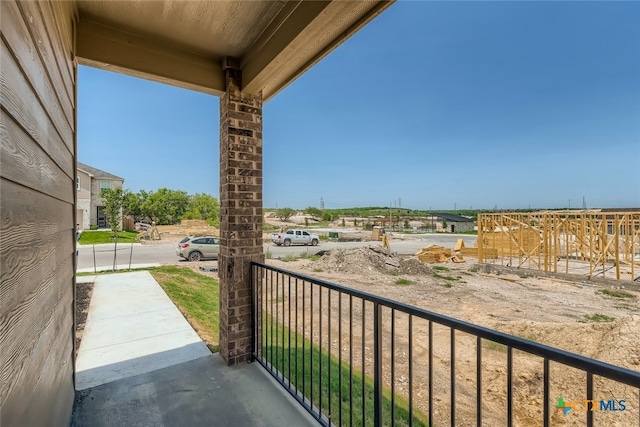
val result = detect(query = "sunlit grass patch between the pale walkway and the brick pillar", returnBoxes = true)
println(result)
[150,265,220,353]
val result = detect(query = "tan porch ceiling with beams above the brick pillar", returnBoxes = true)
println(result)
[75,0,393,100]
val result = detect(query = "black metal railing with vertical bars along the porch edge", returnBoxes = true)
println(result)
[251,263,640,426]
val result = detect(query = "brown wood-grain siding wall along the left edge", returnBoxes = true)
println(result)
[0,0,77,426]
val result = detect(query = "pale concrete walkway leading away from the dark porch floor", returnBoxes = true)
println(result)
[76,271,211,390]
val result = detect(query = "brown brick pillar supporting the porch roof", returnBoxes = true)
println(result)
[218,69,264,365]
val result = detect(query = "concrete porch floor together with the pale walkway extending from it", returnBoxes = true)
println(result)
[71,272,318,427]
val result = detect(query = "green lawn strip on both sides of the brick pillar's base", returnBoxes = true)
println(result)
[149,266,428,426]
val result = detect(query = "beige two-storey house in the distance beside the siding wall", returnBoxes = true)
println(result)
[76,162,124,230]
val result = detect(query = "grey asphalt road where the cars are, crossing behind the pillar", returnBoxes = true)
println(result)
[78,234,477,271]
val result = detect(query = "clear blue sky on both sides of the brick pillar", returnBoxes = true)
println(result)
[78,1,640,210]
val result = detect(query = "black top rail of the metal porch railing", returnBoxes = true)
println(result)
[251,261,640,388]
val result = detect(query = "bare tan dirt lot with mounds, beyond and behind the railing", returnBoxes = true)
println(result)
[267,248,640,426]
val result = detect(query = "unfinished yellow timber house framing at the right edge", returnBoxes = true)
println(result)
[478,211,640,281]
